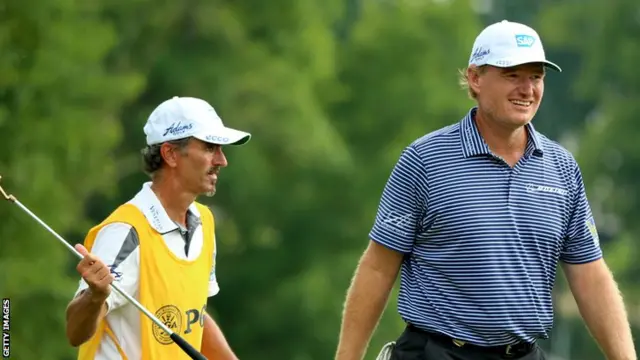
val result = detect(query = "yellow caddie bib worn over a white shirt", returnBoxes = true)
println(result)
[78,203,215,360]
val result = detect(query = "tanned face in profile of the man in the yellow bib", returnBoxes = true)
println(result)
[176,139,227,196]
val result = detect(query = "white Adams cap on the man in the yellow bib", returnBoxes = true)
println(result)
[144,96,251,145]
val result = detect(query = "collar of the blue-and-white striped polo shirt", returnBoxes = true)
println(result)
[460,107,543,157]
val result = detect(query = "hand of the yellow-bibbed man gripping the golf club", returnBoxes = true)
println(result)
[75,244,114,302]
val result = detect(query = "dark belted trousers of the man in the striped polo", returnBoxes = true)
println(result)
[391,326,546,360]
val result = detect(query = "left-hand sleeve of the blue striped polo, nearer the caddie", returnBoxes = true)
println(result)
[369,145,428,253]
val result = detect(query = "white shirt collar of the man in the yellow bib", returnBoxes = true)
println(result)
[131,182,200,234]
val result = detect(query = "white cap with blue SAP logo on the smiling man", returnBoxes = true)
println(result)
[469,20,562,71]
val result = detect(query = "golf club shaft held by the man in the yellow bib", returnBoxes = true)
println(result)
[7,196,206,360]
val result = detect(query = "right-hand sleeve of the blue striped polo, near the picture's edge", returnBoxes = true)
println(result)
[560,163,602,264]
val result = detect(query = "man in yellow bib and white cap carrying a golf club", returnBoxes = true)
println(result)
[67,97,251,360]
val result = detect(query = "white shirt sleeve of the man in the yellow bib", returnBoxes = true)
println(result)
[75,223,140,314]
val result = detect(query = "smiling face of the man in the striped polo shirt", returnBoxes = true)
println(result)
[470,63,545,128]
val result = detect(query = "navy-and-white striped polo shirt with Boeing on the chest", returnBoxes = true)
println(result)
[369,108,602,346]
